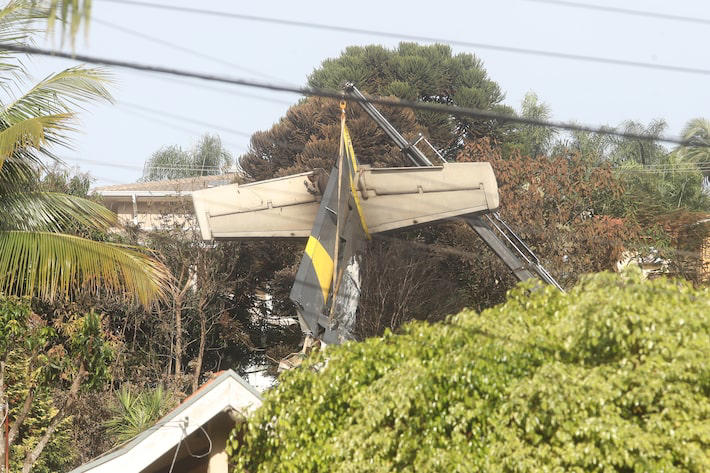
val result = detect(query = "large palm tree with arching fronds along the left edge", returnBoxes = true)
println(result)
[0,0,169,305]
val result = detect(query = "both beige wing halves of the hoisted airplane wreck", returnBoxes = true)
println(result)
[192,163,498,240]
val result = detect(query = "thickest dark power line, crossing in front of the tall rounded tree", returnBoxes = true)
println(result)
[0,43,710,147]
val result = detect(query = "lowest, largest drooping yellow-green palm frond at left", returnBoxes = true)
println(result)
[0,231,170,307]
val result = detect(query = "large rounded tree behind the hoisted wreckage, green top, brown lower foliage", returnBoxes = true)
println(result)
[240,43,512,180]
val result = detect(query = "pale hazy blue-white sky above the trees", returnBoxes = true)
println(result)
[22,0,710,185]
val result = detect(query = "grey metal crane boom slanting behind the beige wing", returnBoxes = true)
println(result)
[345,84,563,291]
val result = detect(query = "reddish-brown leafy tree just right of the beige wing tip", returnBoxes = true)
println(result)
[459,136,642,288]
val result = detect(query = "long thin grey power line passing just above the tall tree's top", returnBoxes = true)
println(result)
[101,0,710,75]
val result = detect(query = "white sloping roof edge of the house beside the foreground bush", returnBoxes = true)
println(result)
[69,370,261,473]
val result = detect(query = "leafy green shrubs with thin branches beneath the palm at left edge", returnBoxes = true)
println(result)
[0,297,115,473]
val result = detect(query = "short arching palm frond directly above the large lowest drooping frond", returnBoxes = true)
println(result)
[0,192,116,232]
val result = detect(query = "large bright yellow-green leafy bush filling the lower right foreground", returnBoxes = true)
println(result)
[229,272,710,473]
